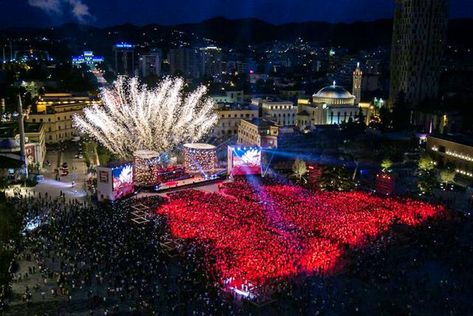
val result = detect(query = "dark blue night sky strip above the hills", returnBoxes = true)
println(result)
[0,0,473,27]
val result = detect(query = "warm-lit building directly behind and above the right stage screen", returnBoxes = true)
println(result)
[238,118,279,148]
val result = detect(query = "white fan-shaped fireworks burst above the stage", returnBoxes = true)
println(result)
[73,77,218,159]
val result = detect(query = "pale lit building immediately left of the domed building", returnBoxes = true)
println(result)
[251,98,297,126]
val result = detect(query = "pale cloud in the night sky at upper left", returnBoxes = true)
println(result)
[28,0,92,23]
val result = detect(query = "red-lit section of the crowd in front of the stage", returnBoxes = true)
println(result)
[157,178,444,292]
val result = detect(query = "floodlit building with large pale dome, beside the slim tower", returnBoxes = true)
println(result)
[296,82,360,128]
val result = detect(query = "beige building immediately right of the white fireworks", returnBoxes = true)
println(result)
[212,103,258,137]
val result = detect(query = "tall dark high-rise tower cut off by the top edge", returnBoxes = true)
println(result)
[389,0,449,106]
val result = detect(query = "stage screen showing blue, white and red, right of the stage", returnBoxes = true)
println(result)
[231,147,261,176]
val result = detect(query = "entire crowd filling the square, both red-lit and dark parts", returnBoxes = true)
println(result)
[0,178,473,315]
